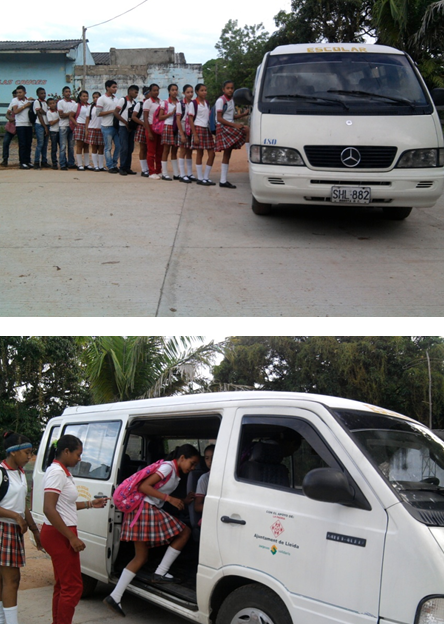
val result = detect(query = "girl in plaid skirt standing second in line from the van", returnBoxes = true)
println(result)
[188,84,215,186]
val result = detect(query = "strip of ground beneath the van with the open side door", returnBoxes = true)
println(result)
[18,583,188,624]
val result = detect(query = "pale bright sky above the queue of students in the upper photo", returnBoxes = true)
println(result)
[0,0,290,63]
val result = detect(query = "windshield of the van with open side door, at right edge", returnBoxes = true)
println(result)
[337,410,444,524]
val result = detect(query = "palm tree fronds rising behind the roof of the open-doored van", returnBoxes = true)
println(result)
[79,336,221,403]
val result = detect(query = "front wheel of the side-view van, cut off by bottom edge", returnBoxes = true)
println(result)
[216,584,292,624]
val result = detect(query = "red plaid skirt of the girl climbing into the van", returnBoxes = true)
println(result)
[120,502,185,548]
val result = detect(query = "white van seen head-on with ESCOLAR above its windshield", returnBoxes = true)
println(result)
[234,43,444,219]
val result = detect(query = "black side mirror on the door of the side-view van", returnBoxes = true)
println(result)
[302,468,355,505]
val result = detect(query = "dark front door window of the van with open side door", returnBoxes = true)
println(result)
[237,416,339,494]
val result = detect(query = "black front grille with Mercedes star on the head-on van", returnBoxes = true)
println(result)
[304,145,397,171]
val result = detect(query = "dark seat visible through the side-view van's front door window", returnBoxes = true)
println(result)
[239,442,290,487]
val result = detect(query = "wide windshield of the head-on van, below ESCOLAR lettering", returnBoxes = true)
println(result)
[259,52,433,115]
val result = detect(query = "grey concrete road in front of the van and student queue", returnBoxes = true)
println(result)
[0,169,444,317]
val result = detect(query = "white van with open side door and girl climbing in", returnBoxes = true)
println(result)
[32,392,444,624]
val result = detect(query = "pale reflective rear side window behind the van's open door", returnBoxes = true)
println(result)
[63,421,122,480]
